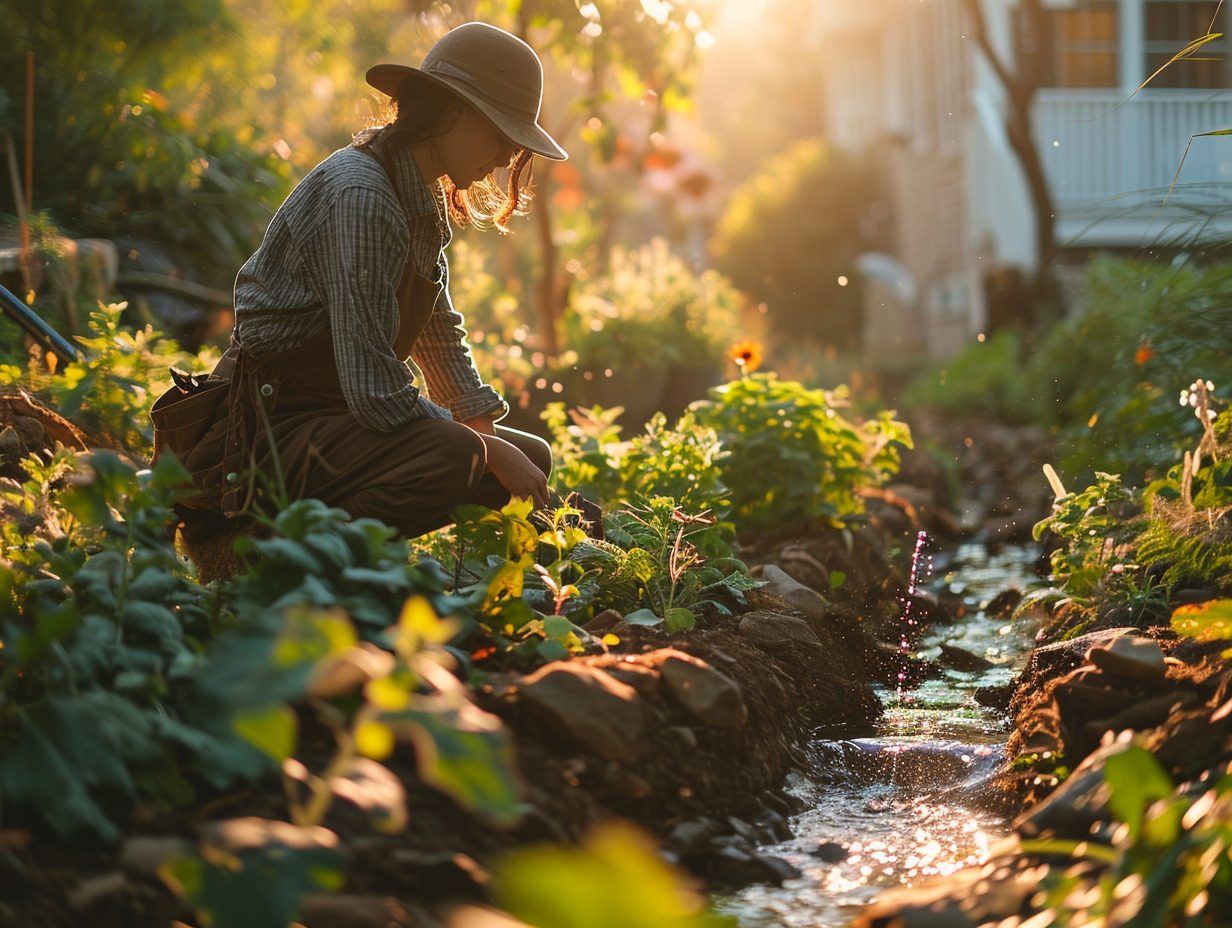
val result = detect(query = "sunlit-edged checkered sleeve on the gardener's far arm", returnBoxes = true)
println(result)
[411,246,509,421]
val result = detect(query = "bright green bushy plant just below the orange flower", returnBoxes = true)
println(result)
[692,373,912,527]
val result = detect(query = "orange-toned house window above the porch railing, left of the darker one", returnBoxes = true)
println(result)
[1041,0,1120,88]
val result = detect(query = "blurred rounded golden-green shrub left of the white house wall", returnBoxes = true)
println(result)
[710,139,890,349]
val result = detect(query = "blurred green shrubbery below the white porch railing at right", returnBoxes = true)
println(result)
[902,255,1232,484]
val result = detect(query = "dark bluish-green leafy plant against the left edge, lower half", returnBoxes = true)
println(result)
[0,454,219,839]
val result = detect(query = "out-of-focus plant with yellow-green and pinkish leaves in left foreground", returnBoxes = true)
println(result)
[159,596,520,928]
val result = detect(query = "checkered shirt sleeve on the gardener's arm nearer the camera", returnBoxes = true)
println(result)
[308,185,450,431]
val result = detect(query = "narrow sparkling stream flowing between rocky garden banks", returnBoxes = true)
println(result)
[716,545,1037,928]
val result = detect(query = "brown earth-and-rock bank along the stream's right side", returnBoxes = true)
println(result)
[856,627,1232,928]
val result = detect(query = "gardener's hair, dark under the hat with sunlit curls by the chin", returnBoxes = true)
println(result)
[351,80,533,234]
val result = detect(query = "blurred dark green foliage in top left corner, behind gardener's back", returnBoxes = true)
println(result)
[0,0,291,287]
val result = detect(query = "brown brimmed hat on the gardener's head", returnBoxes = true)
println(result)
[366,22,569,161]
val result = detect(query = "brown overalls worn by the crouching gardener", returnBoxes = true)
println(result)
[176,260,552,537]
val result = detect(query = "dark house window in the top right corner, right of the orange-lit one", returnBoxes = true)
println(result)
[1143,0,1232,90]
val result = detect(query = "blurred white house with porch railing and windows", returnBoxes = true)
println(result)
[818,0,1232,357]
